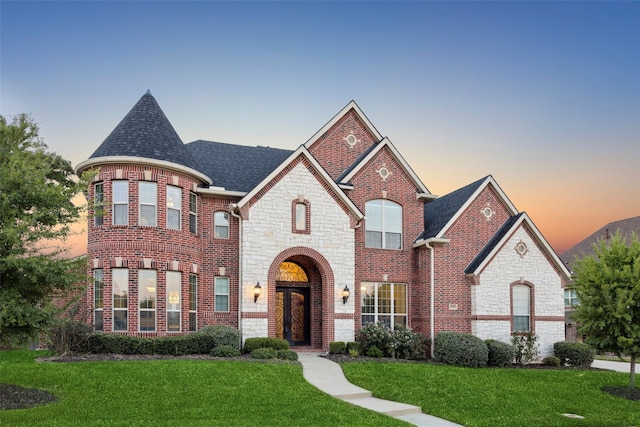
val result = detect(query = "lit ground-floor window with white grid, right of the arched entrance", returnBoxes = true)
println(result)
[360,282,407,329]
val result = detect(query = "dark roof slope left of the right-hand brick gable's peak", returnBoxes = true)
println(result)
[418,177,487,240]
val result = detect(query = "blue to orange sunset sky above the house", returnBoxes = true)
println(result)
[0,0,640,254]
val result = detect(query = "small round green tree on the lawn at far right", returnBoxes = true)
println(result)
[571,231,640,388]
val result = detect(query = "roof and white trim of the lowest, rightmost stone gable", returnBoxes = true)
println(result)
[464,212,571,280]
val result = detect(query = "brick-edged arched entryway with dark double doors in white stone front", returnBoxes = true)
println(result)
[268,248,334,349]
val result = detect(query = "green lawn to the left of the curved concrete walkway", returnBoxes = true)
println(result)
[0,351,407,427]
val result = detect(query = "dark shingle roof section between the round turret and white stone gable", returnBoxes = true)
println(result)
[185,140,293,192]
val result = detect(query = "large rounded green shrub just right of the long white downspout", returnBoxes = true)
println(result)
[434,332,489,368]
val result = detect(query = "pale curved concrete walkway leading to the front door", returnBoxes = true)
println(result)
[298,353,460,427]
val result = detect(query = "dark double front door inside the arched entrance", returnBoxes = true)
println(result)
[276,287,309,345]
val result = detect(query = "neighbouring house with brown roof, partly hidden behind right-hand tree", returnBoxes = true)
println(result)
[561,216,640,341]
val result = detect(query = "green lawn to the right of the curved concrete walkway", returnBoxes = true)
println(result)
[342,362,640,427]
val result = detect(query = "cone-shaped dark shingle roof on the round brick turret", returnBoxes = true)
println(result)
[89,92,201,174]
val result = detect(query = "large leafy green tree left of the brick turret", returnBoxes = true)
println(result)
[0,114,86,345]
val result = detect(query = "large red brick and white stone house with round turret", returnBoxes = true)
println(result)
[76,92,569,354]
